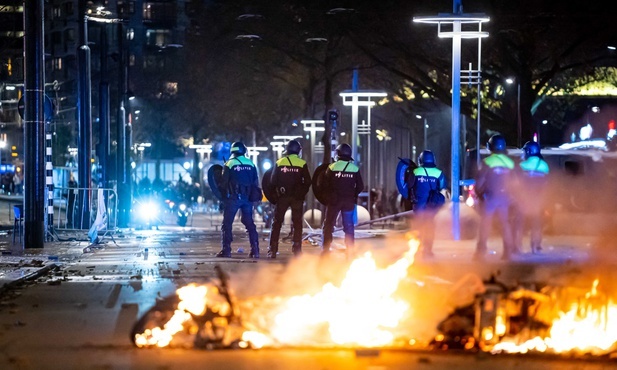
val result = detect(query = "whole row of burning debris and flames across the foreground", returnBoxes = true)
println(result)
[131,234,617,355]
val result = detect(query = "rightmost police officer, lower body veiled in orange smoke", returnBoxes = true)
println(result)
[513,141,549,253]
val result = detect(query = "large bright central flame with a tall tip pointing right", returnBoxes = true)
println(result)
[241,239,418,347]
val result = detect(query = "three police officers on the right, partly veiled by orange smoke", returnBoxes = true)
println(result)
[406,135,549,260]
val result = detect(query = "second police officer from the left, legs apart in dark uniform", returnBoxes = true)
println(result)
[268,140,311,258]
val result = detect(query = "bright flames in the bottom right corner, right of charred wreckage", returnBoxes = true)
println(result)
[492,279,617,355]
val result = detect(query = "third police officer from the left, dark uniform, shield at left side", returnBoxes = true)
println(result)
[321,144,364,256]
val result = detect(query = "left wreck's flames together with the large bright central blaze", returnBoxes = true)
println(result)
[134,239,419,348]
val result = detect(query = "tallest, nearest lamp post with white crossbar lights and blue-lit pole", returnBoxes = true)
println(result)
[413,0,490,240]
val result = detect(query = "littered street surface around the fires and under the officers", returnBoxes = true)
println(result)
[0,205,616,369]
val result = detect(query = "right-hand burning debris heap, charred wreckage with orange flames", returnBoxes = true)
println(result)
[432,277,617,355]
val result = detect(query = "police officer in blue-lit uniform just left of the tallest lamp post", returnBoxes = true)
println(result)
[407,150,446,258]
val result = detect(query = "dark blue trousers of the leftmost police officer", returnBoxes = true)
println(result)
[221,199,259,252]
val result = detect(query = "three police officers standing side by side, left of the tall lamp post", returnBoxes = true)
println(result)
[216,140,364,258]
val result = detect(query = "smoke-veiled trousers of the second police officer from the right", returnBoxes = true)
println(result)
[476,199,514,256]
